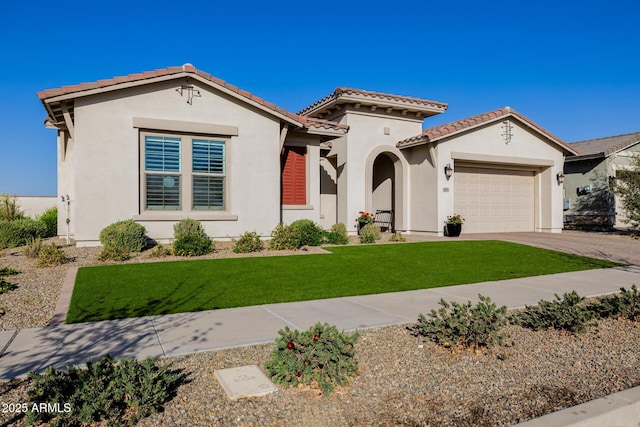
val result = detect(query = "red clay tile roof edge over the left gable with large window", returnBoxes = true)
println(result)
[38,64,348,131]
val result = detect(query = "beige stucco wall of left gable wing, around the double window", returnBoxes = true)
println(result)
[69,81,280,245]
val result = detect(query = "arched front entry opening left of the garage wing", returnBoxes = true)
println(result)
[367,150,404,230]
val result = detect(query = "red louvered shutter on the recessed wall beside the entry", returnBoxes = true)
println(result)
[282,147,307,205]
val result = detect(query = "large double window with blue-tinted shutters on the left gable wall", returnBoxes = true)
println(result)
[141,133,227,212]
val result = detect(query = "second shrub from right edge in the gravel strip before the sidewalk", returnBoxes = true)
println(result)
[511,291,596,333]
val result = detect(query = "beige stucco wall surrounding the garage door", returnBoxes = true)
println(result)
[411,120,564,234]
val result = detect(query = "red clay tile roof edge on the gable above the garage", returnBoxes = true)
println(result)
[397,107,575,152]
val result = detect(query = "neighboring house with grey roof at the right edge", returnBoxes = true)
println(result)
[564,132,640,228]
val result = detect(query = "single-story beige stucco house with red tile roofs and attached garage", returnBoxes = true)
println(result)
[38,64,577,245]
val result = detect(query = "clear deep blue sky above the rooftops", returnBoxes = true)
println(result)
[0,0,640,195]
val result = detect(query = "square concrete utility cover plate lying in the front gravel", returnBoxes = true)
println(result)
[213,365,277,399]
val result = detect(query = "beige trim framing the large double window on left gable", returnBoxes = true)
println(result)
[138,129,230,216]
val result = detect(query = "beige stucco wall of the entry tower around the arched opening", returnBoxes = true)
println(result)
[334,107,422,234]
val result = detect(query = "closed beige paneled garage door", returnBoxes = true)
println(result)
[454,166,535,233]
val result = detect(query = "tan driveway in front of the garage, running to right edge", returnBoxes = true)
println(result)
[411,232,640,265]
